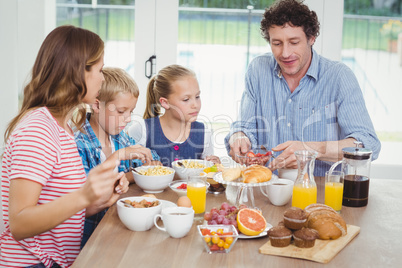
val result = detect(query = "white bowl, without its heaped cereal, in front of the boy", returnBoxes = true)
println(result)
[133,166,175,194]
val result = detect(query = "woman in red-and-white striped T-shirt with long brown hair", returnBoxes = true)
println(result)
[0,26,150,267]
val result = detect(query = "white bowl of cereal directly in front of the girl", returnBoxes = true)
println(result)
[172,159,214,180]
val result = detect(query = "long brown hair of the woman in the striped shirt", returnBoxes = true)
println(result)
[4,25,104,142]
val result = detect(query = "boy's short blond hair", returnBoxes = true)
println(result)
[97,67,140,103]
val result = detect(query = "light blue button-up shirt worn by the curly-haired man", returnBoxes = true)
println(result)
[225,50,381,176]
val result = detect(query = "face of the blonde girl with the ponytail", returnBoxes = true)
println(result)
[165,76,201,123]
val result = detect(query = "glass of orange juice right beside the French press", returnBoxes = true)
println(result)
[325,171,344,212]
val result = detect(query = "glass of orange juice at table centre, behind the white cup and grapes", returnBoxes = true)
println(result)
[187,172,209,221]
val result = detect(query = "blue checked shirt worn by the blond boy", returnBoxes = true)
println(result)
[74,120,159,248]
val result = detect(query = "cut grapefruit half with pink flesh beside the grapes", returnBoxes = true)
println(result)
[237,208,267,236]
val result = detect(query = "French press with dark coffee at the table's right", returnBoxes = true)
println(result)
[329,141,373,207]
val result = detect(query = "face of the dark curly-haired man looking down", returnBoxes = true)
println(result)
[268,24,315,79]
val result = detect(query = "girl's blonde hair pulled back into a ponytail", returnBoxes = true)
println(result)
[143,64,196,119]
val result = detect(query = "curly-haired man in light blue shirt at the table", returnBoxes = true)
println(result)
[225,0,381,176]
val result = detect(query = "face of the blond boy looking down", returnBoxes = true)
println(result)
[95,92,138,135]
